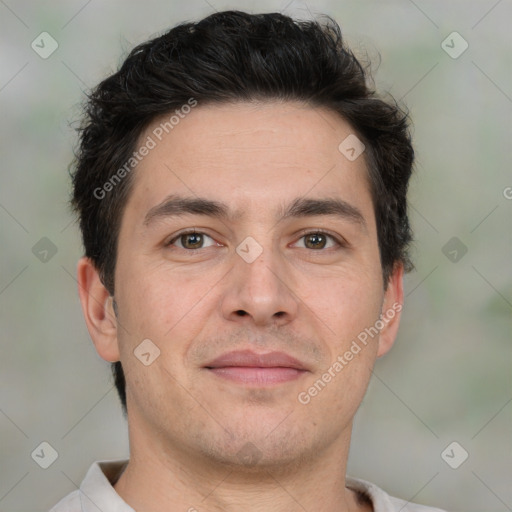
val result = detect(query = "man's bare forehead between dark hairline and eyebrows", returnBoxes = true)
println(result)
[124,102,371,224]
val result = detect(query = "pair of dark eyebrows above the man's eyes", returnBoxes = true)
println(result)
[144,195,367,230]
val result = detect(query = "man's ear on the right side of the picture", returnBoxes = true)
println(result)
[377,264,404,357]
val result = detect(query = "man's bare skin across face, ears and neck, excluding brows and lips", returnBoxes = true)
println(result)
[78,102,403,512]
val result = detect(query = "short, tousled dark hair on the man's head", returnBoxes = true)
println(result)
[71,11,414,415]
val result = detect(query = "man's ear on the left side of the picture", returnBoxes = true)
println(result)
[77,257,120,362]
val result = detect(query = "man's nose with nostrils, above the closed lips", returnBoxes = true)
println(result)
[222,243,299,326]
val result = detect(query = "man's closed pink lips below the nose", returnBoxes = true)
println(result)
[204,350,309,386]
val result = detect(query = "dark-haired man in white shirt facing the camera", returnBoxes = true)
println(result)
[52,11,446,512]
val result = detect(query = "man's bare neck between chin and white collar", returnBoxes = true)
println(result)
[114,416,372,512]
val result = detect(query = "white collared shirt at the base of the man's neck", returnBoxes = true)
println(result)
[50,460,444,512]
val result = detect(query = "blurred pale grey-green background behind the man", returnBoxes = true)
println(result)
[0,0,512,512]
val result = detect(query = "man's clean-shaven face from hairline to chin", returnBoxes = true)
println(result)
[80,103,401,472]
